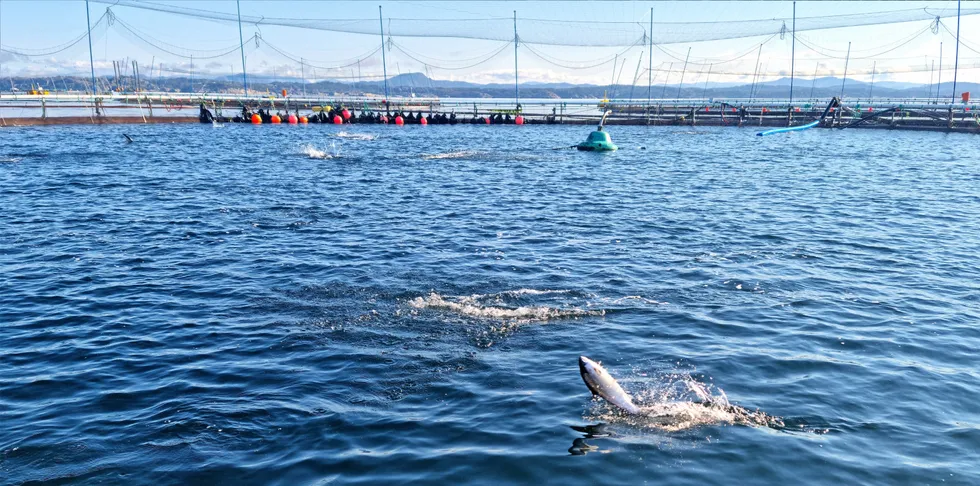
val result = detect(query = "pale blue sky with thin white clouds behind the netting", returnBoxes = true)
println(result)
[0,0,980,87]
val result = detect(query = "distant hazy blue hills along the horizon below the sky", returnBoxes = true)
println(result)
[3,73,980,100]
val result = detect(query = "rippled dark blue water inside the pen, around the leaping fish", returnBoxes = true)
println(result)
[0,124,980,486]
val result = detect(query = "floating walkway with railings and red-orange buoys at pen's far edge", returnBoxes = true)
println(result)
[0,92,980,133]
